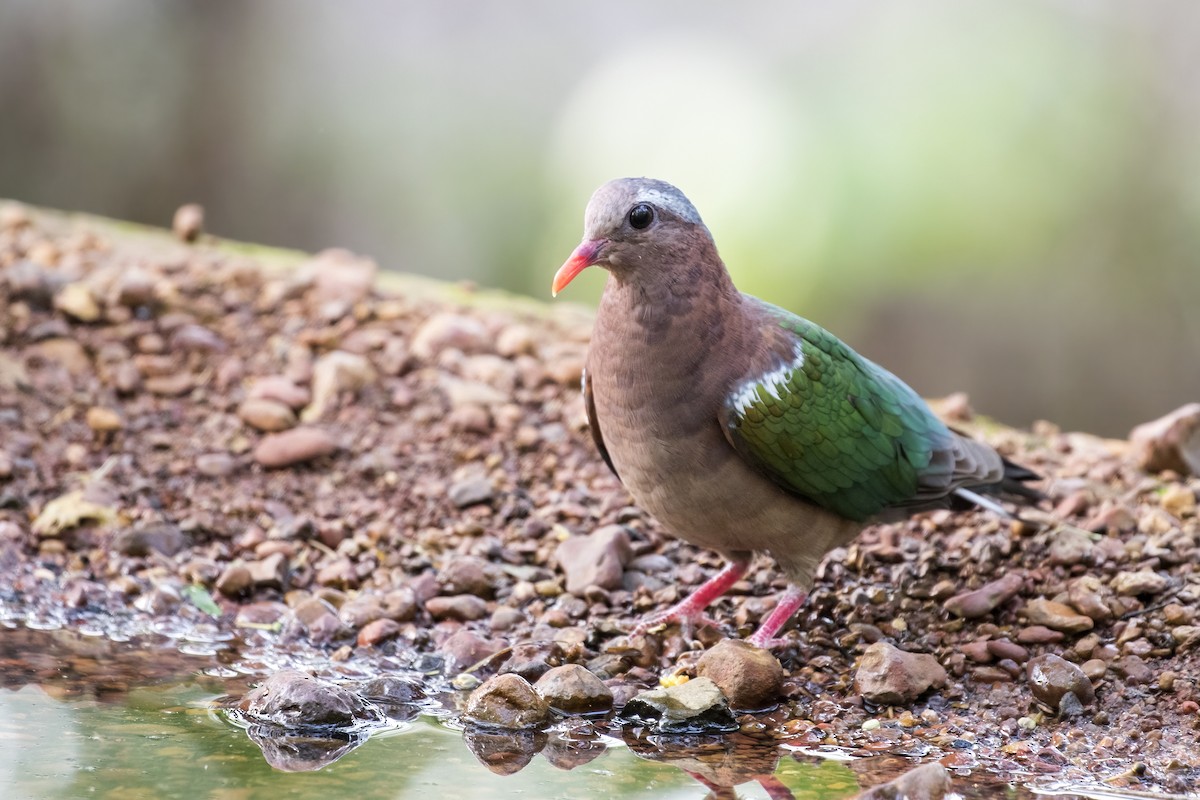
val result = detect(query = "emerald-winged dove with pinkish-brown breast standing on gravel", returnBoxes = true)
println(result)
[552,178,1038,648]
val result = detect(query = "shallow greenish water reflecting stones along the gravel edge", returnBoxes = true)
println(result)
[0,627,1180,800]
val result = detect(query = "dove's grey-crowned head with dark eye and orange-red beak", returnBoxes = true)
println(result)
[551,178,713,295]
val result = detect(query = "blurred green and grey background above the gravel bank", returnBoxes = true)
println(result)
[0,0,1200,435]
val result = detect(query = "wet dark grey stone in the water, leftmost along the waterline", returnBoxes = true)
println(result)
[238,669,383,730]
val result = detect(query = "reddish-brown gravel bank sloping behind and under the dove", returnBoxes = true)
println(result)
[0,204,1200,792]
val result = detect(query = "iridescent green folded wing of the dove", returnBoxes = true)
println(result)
[721,295,964,519]
